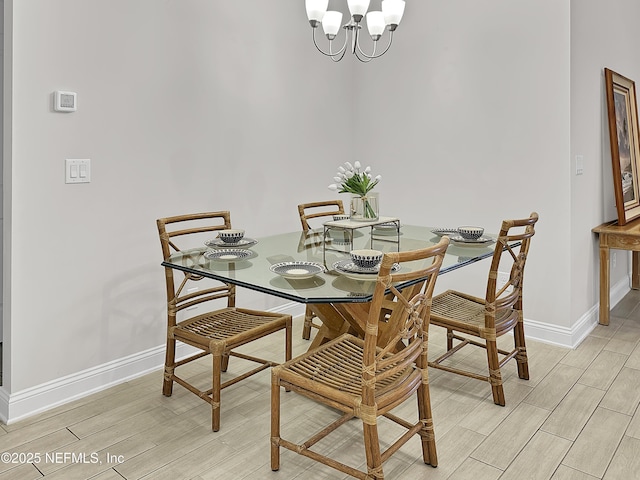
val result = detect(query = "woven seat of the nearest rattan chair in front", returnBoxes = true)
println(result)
[276,334,420,407]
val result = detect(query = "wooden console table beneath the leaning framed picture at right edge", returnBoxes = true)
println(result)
[591,219,640,325]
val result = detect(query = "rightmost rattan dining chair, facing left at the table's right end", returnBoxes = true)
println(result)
[429,212,538,406]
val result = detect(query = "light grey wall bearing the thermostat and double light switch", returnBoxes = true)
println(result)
[5,0,352,392]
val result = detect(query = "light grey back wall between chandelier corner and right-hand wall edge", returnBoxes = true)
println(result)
[355,0,571,328]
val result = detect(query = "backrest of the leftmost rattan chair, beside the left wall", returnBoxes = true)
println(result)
[156,211,235,325]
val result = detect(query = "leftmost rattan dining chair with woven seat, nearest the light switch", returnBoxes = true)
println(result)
[157,211,291,431]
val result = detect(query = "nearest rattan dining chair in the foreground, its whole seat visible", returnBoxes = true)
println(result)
[271,237,449,479]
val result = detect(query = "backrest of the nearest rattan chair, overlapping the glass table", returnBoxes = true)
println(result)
[362,236,449,405]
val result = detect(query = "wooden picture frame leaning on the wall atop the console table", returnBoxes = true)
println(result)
[604,68,640,225]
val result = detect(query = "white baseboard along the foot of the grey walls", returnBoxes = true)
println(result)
[0,278,630,424]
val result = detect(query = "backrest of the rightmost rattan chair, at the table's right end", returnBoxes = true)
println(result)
[485,212,538,320]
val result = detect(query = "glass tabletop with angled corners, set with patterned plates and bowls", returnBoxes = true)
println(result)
[162,225,496,303]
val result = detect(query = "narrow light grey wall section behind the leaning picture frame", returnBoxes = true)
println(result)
[571,0,640,319]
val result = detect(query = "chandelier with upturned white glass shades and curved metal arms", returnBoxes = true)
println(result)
[306,0,404,62]
